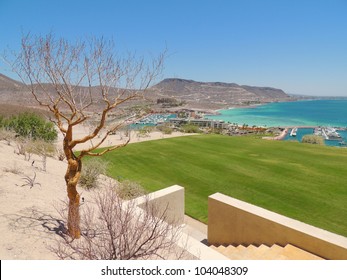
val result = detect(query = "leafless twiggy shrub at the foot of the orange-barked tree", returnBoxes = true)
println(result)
[51,185,187,260]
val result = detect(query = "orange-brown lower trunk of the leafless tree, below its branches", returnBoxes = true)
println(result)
[65,159,82,239]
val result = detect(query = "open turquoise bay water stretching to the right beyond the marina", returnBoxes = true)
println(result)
[206,99,347,127]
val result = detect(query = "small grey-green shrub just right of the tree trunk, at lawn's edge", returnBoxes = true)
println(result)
[79,158,107,190]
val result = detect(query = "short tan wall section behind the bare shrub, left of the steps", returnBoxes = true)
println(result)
[137,185,184,224]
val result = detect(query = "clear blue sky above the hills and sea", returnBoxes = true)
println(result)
[0,0,347,96]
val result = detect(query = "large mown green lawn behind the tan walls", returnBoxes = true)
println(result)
[92,135,347,236]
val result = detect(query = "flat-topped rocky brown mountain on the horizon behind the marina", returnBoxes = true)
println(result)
[151,78,291,109]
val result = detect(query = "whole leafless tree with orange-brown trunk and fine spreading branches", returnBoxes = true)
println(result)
[7,34,164,238]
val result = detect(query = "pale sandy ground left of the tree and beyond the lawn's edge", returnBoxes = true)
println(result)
[0,128,196,260]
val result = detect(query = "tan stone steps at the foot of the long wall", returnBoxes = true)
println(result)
[210,244,322,260]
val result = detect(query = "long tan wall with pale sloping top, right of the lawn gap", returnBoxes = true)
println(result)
[207,193,347,260]
